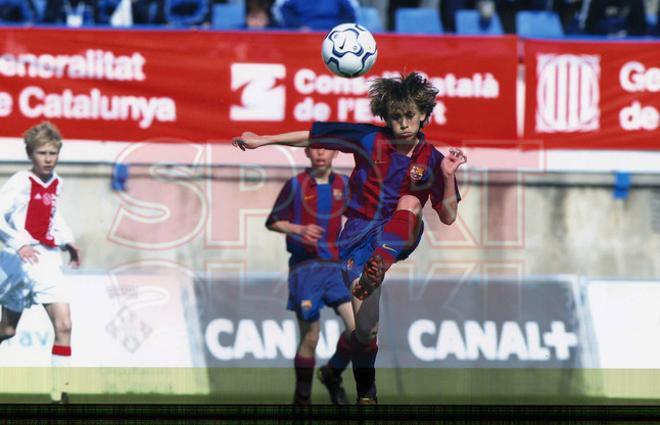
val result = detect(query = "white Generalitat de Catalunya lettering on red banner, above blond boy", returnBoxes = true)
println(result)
[0,49,177,130]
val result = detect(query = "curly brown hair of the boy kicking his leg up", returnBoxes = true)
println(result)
[369,72,438,120]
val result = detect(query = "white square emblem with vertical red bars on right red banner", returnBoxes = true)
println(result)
[536,54,600,133]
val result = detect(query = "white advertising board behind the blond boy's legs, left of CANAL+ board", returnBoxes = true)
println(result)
[0,273,203,368]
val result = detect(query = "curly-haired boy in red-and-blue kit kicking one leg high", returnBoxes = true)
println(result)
[233,73,467,404]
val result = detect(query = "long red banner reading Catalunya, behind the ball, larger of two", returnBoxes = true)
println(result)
[0,28,517,144]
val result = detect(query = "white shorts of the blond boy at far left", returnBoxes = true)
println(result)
[0,245,69,312]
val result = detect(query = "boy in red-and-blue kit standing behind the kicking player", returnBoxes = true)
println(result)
[266,147,355,404]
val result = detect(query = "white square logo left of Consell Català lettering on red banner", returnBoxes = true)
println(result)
[229,63,286,121]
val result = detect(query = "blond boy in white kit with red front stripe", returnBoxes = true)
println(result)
[0,122,80,403]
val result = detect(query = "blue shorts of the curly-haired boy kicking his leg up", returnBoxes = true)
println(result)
[338,217,424,287]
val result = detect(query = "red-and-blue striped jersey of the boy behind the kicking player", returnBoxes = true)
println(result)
[266,169,348,263]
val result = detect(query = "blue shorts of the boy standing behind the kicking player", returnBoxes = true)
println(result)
[286,260,351,322]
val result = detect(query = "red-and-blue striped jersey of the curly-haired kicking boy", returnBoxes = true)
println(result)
[310,122,460,219]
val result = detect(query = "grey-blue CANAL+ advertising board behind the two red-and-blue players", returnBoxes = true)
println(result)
[195,279,590,368]
